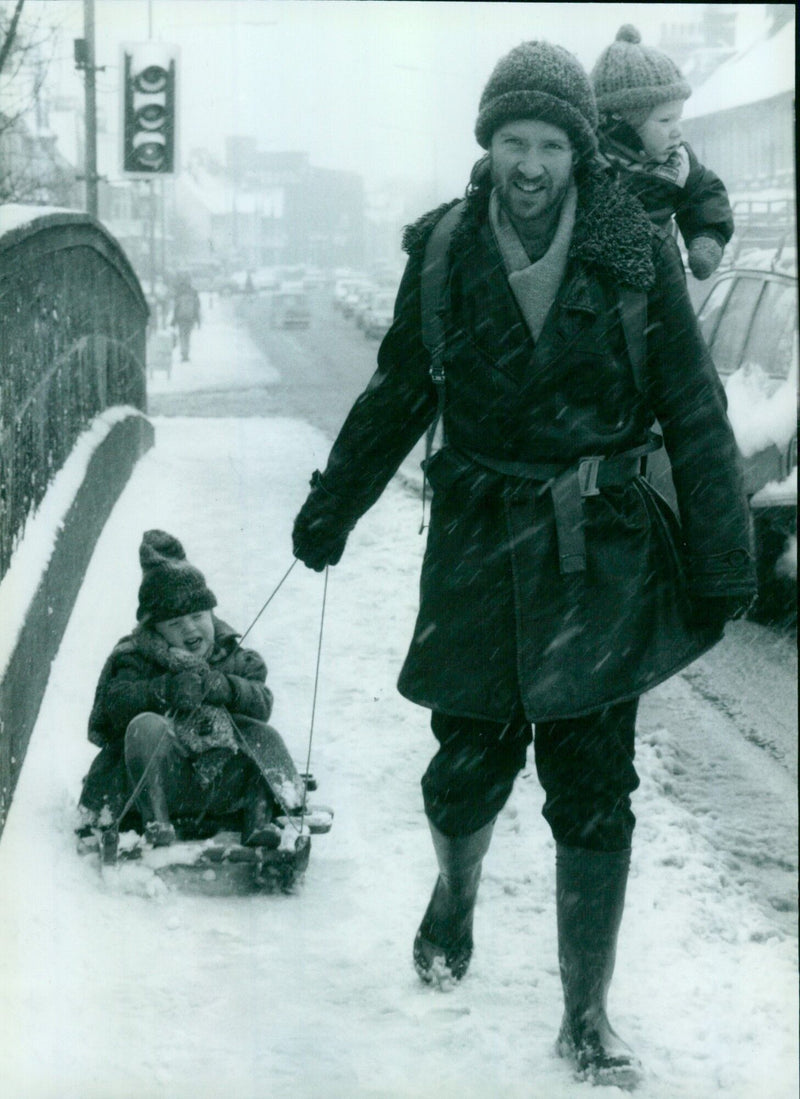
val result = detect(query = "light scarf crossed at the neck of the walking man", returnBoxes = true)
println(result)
[489,182,578,341]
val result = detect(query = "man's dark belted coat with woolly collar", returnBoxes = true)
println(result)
[316,174,755,721]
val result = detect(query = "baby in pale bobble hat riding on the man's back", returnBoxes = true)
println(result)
[591,24,734,279]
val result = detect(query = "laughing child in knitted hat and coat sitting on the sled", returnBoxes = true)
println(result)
[80,531,304,847]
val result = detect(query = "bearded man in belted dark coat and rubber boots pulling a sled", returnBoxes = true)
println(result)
[293,42,755,1086]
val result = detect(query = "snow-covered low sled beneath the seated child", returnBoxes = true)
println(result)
[77,775,333,897]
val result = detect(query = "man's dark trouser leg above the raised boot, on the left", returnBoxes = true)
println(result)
[422,712,532,836]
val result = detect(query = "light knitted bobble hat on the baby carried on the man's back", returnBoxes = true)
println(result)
[591,23,691,121]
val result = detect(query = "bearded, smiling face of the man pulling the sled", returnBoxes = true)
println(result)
[489,119,575,224]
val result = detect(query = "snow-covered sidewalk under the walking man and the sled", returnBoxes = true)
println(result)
[0,303,798,1099]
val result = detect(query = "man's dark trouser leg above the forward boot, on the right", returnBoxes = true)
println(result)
[534,699,638,852]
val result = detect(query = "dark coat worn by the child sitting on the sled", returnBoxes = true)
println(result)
[80,615,273,826]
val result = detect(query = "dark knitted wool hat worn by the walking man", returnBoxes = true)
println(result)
[475,42,598,158]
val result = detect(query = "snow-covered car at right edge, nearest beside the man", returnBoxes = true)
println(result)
[648,256,798,620]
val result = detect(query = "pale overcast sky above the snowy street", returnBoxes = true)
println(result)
[26,0,782,193]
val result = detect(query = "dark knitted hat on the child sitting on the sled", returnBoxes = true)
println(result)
[136,531,216,623]
